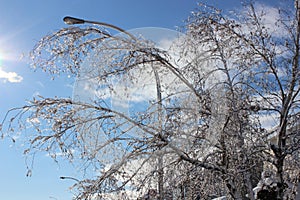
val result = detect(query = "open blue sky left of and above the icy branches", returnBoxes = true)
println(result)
[0,0,282,200]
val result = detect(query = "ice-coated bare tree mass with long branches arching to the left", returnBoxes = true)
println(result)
[0,0,300,199]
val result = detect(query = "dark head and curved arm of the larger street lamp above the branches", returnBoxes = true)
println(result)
[63,16,136,40]
